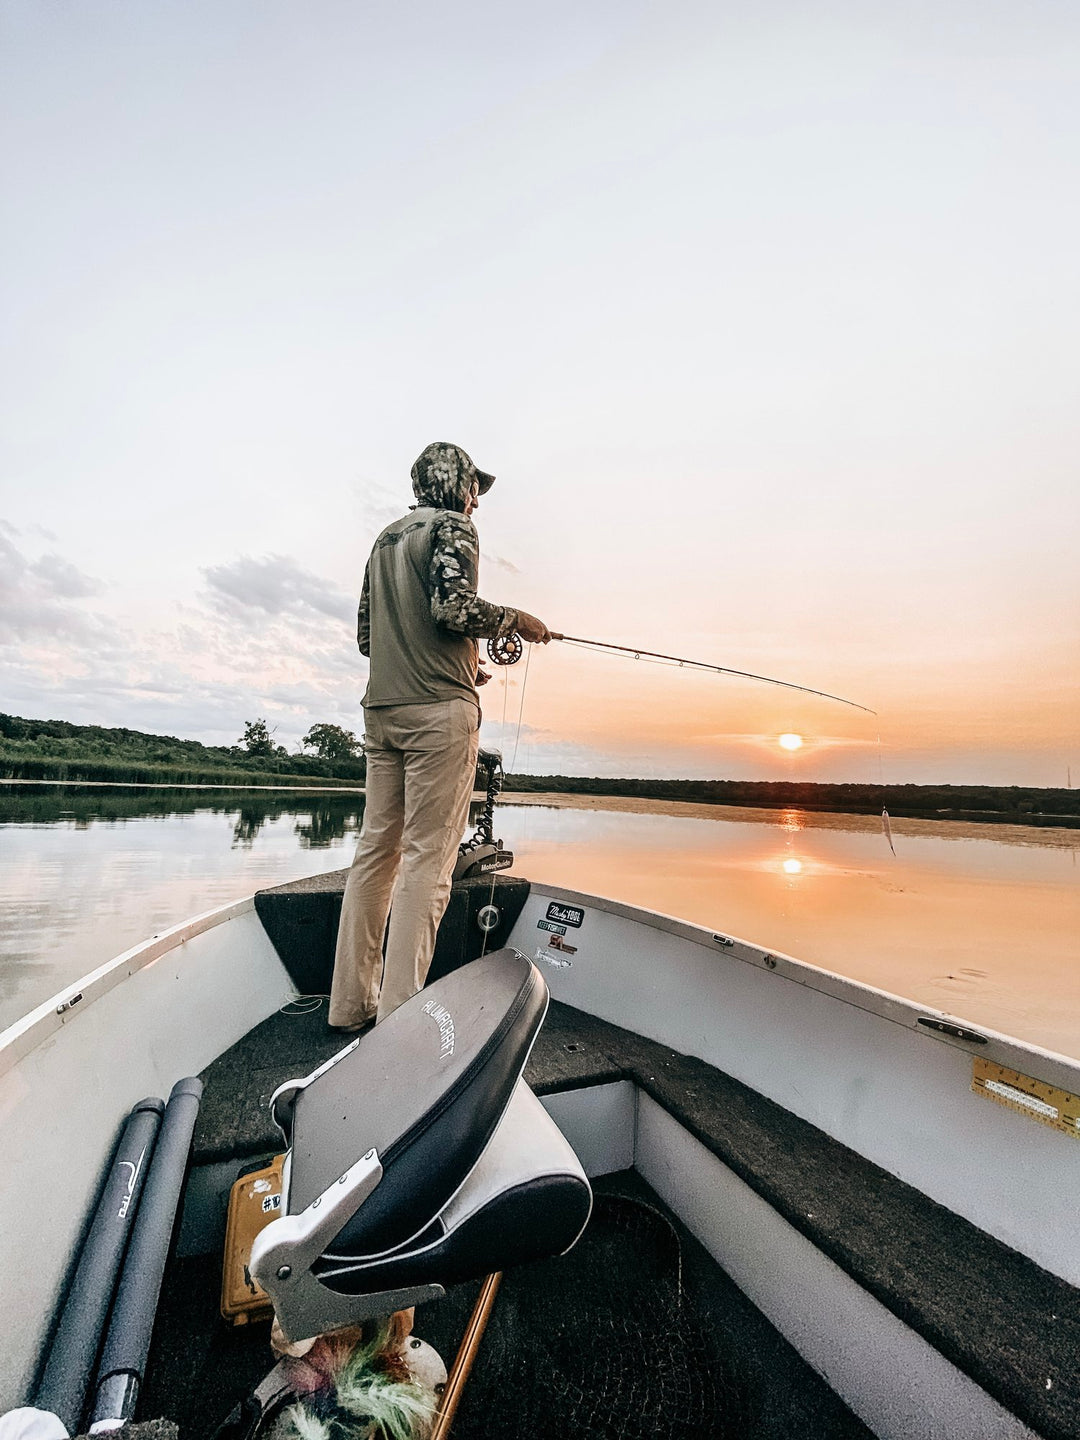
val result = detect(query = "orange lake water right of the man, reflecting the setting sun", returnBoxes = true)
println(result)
[500,796,1080,1056]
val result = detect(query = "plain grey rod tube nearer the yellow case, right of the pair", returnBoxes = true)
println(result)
[91,1076,203,1433]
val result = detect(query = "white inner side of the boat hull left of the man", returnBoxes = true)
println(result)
[0,899,292,1411]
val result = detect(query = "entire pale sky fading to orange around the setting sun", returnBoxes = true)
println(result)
[0,0,1080,785]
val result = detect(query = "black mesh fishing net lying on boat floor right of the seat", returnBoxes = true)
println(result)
[443,1195,737,1440]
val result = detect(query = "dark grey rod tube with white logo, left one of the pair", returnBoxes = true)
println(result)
[35,1096,166,1434]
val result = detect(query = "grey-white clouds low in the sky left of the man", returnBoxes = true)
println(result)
[0,521,366,743]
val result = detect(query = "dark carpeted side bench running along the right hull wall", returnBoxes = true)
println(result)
[539,1015,1080,1440]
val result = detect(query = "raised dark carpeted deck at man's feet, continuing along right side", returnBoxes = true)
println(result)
[182,1002,1080,1440]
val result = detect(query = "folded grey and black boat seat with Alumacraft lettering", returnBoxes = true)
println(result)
[251,949,589,1339]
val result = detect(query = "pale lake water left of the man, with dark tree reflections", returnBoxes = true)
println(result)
[0,785,363,1027]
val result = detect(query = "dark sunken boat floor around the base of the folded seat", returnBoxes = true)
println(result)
[148,1171,873,1440]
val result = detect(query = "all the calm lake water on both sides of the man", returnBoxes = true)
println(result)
[0,785,1080,1056]
